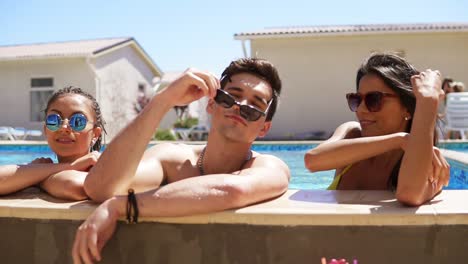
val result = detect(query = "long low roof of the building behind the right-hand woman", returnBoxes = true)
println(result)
[234,23,468,40]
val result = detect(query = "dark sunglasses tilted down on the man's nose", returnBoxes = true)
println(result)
[214,89,273,122]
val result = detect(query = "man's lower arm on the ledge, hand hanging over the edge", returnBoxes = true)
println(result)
[73,156,289,263]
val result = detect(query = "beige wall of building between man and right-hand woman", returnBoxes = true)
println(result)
[251,33,468,137]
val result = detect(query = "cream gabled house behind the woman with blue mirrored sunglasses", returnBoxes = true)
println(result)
[0,38,163,142]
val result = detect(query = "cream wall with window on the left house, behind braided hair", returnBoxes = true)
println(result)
[0,59,95,130]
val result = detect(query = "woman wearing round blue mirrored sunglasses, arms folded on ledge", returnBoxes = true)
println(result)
[0,87,104,200]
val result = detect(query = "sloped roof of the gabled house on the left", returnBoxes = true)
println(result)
[0,37,163,76]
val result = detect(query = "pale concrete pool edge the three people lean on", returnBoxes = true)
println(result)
[0,188,468,226]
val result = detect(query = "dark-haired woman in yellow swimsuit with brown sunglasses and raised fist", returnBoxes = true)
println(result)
[304,54,450,206]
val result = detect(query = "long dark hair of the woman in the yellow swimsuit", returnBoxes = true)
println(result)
[356,53,438,189]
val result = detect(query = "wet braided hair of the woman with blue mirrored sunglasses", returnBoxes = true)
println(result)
[44,86,107,151]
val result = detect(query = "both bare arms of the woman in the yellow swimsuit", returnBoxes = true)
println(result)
[304,70,450,206]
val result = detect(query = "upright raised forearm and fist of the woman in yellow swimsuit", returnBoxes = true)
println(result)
[396,70,450,205]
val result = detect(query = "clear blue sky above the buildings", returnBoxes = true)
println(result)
[0,0,468,75]
